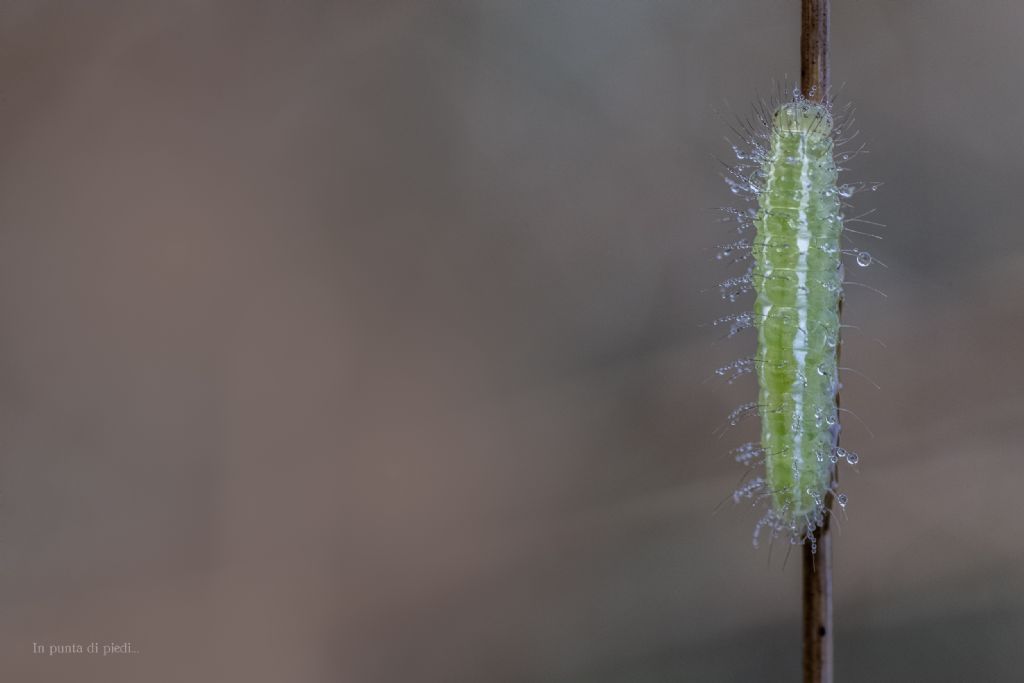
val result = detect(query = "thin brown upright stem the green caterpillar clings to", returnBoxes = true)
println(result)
[800,0,831,683]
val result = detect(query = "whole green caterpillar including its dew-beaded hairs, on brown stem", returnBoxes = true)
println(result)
[716,93,873,545]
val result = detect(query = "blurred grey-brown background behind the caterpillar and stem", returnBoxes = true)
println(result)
[0,0,1024,683]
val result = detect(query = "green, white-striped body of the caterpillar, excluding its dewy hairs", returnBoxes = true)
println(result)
[753,101,843,526]
